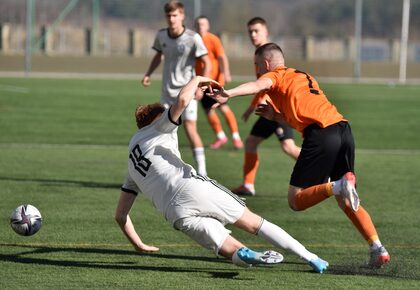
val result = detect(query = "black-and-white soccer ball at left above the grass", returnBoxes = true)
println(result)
[10,204,42,236]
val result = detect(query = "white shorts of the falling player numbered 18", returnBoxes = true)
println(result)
[165,176,245,254]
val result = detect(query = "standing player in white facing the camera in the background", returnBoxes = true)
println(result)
[142,1,211,175]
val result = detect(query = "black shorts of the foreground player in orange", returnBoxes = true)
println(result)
[290,122,354,188]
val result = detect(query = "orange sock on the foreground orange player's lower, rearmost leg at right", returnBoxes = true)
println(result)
[344,206,378,245]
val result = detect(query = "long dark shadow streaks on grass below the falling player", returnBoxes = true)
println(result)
[0,245,249,280]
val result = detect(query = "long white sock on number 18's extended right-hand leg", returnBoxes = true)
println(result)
[257,220,318,262]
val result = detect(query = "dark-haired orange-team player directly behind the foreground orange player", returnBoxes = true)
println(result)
[232,17,300,195]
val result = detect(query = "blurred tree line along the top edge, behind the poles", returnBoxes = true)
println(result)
[0,0,420,39]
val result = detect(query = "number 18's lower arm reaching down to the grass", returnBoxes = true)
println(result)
[115,191,159,252]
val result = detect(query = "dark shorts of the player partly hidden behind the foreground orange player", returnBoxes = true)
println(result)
[251,117,293,141]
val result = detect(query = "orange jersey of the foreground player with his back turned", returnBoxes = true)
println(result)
[261,66,346,133]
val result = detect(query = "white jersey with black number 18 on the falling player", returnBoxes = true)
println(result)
[122,110,196,216]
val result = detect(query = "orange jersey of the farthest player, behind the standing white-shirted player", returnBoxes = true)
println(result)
[195,32,225,86]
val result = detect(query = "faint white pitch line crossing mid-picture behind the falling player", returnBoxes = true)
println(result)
[0,143,420,155]
